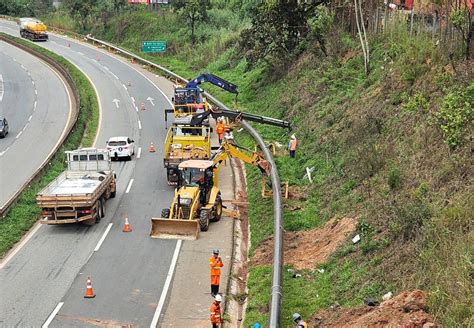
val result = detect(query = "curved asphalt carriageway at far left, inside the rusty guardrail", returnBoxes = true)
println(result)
[0,41,71,207]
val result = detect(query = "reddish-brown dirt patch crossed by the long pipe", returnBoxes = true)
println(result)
[251,218,357,270]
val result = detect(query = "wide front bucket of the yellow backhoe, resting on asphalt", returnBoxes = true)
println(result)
[150,218,200,240]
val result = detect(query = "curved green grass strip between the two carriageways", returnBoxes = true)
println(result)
[0,33,99,258]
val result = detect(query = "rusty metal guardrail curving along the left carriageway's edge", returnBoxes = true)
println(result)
[0,35,80,218]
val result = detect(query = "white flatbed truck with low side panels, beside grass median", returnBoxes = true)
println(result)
[36,148,116,225]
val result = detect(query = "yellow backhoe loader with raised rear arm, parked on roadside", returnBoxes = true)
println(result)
[150,141,271,240]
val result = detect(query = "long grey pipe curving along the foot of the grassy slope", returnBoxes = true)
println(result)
[85,35,283,328]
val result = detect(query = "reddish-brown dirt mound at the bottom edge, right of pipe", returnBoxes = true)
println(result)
[308,290,438,328]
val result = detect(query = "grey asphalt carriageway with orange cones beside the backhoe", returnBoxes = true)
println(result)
[0,21,180,327]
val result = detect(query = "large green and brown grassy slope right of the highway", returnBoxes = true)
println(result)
[42,10,474,327]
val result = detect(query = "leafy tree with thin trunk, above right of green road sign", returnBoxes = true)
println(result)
[172,0,211,44]
